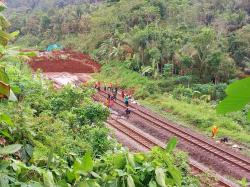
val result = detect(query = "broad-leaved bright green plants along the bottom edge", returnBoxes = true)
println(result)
[0,135,197,187]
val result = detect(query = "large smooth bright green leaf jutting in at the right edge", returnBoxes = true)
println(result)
[217,78,250,120]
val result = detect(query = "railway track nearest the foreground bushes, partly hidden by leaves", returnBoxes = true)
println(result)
[107,117,239,187]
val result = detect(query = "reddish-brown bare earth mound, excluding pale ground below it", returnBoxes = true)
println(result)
[28,50,100,73]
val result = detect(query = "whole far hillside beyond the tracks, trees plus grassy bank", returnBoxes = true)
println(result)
[7,0,250,143]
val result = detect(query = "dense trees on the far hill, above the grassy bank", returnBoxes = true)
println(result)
[7,0,250,80]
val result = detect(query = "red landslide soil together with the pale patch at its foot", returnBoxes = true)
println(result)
[28,50,101,87]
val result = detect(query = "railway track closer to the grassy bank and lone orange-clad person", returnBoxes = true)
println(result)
[94,91,250,183]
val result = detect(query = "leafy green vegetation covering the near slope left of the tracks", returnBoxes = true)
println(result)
[0,3,199,187]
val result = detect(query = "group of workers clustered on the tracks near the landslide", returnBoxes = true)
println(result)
[94,82,131,118]
